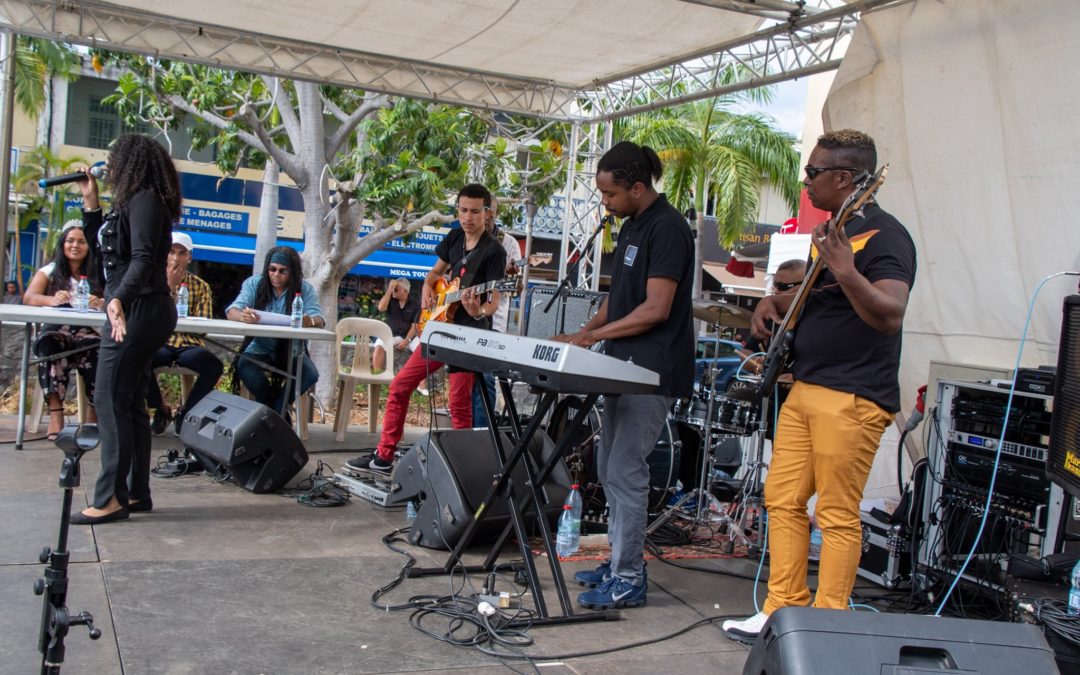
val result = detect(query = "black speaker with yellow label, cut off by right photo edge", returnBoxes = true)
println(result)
[1047,295,1080,497]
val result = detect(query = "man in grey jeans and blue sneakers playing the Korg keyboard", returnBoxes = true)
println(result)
[554,141,693,609]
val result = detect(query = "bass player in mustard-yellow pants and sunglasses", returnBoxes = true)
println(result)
[724,130,916,640]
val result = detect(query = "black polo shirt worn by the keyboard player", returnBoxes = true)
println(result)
[607,194,693,396]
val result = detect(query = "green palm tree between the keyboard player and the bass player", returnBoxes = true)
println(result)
[616,90,800,308]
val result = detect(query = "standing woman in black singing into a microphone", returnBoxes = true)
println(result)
[71,134,180,525]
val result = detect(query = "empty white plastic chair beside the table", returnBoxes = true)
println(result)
[334,316,394,442]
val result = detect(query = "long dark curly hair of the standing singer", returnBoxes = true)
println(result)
[108,134,180,220]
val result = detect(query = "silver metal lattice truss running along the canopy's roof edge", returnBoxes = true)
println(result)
[0,0,909,123]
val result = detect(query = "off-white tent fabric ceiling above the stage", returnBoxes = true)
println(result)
[110,0,762,89]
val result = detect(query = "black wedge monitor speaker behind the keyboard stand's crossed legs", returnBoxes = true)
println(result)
[391,429,570,550]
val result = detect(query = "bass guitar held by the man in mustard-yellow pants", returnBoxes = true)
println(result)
[757,164,889,396]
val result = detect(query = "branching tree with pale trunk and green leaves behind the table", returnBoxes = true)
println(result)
[95,53,563,391]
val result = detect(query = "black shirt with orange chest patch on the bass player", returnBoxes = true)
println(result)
[792,199,916,413]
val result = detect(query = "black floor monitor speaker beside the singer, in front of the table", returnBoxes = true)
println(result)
[180,391,308,492]
